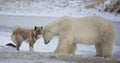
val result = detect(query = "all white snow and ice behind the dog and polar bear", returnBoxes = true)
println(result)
[0,0,120,63]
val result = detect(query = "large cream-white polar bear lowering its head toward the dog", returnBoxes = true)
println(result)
[42,16,115,58]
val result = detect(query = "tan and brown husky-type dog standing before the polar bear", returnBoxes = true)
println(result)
[11,26,42,51]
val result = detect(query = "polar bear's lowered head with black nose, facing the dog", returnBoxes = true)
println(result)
[42,26,57,44]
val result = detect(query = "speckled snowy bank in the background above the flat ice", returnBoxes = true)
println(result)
[0,0,120,21]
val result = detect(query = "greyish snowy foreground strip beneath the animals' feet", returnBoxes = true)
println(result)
[0,46,120,63]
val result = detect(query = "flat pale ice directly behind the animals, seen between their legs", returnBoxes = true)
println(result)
[0,15,120,60]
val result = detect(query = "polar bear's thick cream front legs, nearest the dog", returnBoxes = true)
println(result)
[55,38,76,54]
